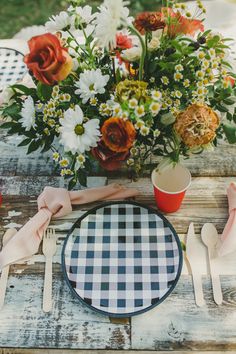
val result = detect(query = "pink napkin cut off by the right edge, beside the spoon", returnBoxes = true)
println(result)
[218,183,236,256]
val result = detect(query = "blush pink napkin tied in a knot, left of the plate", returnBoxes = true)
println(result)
[0,184,139,269]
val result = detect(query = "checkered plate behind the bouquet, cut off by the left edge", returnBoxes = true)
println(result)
[0,48,27,91]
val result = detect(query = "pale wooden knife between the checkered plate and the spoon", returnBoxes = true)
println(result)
[186,223,205,307]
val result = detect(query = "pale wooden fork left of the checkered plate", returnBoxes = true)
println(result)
[43,229,57,312]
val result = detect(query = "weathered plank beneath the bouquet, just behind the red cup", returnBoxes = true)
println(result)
[0,128,236,176]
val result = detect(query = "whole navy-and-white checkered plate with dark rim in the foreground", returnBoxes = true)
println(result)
[62,202,182,317]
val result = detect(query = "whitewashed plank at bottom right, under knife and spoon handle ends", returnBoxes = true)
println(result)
[132,276,236,351]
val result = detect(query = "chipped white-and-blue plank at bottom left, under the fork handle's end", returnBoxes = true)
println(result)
[0,274,130,350]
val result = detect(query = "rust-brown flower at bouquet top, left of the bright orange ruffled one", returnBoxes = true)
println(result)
[134,12,165,34]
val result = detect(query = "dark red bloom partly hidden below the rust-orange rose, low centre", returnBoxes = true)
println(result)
[92,141,129,171]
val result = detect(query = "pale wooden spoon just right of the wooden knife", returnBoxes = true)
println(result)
[201,223,223,305]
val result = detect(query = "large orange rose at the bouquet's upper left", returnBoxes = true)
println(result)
[25,33,73,85]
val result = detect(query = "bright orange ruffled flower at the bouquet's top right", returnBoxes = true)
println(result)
[162,8,204,37]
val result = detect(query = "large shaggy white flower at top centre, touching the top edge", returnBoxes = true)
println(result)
[94,0,132,49]
